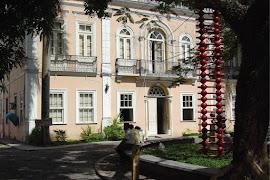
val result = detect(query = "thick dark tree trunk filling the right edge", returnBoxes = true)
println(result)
[212,1,269,180]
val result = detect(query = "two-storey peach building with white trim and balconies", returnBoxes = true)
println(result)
[0,0,239,141]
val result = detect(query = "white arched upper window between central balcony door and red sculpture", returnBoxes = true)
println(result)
[179,34,193,61]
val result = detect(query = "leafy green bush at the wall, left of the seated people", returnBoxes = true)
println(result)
[104,112,125,141]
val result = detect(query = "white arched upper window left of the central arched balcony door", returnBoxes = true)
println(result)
[118,28,133,59]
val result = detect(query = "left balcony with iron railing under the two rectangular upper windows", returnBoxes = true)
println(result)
[50,55,97,76]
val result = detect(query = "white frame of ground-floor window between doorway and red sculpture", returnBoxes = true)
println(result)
[180,92,196,122]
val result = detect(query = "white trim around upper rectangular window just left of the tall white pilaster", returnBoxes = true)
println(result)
[75,20,96,56]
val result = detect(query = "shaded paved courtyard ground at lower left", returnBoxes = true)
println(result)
[0,143,117,179]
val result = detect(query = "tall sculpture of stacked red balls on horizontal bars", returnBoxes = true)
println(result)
[197,9,225,157]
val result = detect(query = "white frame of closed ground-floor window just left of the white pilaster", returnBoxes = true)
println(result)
[76,89,97,124]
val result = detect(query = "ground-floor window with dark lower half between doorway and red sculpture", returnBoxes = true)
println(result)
[180,93,195,121]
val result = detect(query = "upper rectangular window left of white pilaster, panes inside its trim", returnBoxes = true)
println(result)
[79,24,93,56]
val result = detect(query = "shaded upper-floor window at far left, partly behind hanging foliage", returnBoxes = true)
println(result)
[51,22,64,55]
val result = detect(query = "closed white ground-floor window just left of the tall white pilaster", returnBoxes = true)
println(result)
[76,90,96,124]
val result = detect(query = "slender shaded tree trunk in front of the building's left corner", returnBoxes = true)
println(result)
[41,35,51,146]
